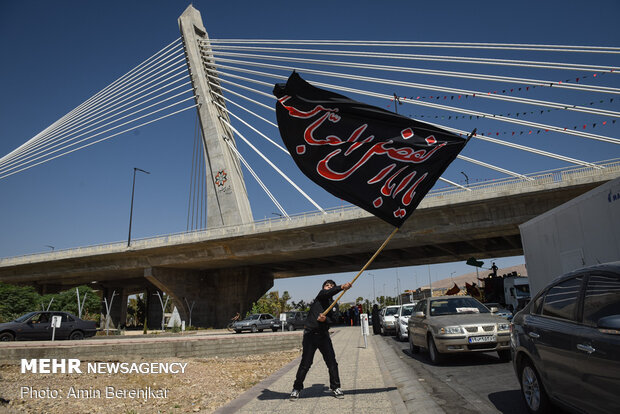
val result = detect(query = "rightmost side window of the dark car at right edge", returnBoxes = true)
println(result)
[583,275,620,326]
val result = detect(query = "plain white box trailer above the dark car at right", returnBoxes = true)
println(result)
[519,178,620,297]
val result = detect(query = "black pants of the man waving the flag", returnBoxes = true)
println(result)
[293,330,340,390]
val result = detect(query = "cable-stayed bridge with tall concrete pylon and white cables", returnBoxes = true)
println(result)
[0,7,620,324]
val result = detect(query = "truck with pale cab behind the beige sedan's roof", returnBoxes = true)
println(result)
[482,272,530,312]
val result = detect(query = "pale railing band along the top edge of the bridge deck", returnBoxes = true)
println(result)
[0,158,620,266]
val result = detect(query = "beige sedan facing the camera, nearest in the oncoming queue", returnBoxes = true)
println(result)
[408,296,510,364]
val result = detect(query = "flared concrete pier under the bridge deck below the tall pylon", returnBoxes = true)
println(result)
[144,267,273,328]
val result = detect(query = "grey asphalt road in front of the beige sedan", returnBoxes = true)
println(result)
[383,336,527,414]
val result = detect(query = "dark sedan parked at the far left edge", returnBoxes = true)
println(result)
[0,311,97,341]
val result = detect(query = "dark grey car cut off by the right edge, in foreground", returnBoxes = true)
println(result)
[511,262,620,414]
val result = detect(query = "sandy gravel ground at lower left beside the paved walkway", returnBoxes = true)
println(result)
[0,350,300,414]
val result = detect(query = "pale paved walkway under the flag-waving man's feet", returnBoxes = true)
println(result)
[216,327,443,414]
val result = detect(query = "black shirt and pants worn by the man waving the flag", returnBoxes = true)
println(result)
[293,286,342,390]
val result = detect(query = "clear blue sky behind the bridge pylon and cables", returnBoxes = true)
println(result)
[0,0,620,300]
